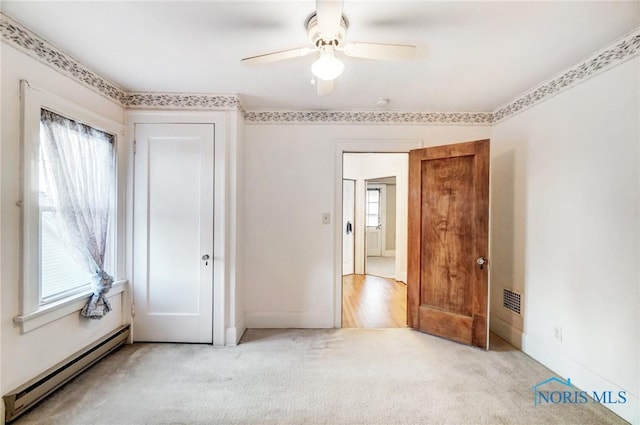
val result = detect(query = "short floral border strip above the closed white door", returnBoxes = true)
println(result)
[122,92,240,109]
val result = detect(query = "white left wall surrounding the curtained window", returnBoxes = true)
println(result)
[0,44,126,394]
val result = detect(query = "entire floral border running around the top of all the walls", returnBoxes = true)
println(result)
[0,12,640,125]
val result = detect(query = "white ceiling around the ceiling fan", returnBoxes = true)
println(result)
[0,0,640,112]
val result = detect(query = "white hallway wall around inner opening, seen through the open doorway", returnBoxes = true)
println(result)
[342,153,409,282]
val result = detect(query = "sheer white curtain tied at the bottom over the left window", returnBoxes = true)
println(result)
[40,109,115,319]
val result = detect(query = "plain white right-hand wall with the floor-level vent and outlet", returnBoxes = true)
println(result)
[491,57,640,423]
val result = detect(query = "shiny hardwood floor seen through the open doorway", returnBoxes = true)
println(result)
[342,274,407,328]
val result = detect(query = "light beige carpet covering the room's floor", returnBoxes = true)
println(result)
[15,329,625,425]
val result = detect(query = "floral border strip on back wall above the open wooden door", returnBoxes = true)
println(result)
[245,111,493,125]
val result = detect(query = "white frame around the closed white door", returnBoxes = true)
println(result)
[123,111,230,345]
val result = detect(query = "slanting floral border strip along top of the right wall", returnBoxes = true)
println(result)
[493,28,640,123]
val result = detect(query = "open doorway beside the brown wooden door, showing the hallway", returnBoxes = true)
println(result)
[340,153,408,328]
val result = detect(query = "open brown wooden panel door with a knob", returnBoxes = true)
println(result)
[407,140,489,348]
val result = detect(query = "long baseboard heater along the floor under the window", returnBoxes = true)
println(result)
[2,325,129,422]
